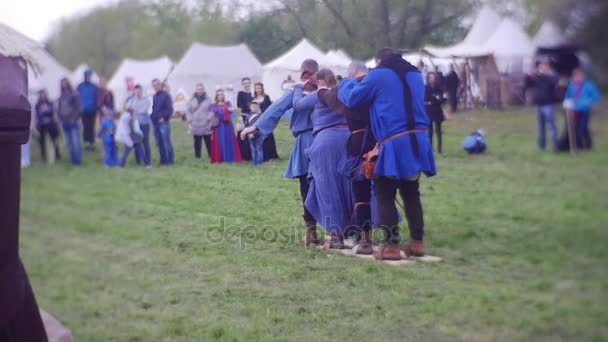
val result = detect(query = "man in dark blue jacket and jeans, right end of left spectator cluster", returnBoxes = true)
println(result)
[150,79,174,166]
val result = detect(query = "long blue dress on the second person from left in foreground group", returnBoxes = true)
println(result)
[293,87,355,236]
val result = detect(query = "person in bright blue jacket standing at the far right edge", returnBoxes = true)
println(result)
[564,69,601,150]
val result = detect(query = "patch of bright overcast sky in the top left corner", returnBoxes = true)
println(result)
[0,0,115,42]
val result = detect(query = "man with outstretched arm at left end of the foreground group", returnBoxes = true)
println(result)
[241,59,320,245]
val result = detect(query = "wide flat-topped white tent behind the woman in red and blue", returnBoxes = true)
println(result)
[169,43,262,100]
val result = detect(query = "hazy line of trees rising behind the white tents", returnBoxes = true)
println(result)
[46,0,608,83]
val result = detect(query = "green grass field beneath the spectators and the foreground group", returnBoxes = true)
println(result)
[21,107,608,341]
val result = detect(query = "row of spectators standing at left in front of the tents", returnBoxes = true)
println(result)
[34,70,278,168]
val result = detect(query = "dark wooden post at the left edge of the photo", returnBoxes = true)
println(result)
[0,55,47,342]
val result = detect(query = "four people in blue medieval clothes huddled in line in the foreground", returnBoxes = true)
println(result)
[240,48,436,260]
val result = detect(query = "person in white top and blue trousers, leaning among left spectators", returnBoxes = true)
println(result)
[116,110,151,168]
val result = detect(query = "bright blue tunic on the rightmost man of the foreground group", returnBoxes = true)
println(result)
[338,68,437,179]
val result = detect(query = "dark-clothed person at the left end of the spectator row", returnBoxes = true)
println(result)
[35,90,61,161]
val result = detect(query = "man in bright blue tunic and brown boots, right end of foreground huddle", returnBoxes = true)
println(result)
[338,48,436,260]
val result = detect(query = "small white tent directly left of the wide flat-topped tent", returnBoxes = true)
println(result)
[108,56,173,89]
